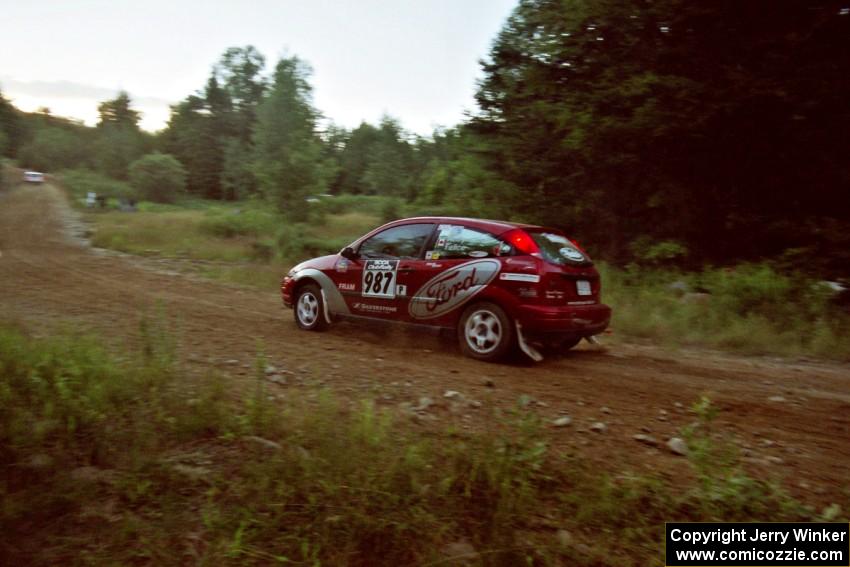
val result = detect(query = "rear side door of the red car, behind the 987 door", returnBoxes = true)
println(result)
[406,223,509,326]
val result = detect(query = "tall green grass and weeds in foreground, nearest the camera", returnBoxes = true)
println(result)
[0,318,840,566]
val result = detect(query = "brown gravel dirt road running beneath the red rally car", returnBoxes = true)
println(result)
[0,184,850,503]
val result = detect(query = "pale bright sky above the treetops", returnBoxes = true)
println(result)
[0,0,517,135]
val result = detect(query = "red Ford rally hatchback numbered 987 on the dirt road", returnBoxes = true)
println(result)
[280,217,611,361]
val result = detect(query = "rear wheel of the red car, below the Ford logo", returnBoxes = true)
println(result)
[457,301,516,362]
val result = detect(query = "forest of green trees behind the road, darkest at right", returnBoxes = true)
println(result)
[0,0,850,275]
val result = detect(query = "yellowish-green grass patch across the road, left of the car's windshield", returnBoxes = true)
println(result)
[86,194,381,276]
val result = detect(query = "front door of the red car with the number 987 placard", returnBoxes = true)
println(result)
[340,223,435,320]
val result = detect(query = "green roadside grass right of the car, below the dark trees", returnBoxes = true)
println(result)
[600,264,850,360]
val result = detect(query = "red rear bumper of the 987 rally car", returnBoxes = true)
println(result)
[510,303,611,337]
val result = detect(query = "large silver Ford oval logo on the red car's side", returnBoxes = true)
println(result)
[409,260,502,319]
